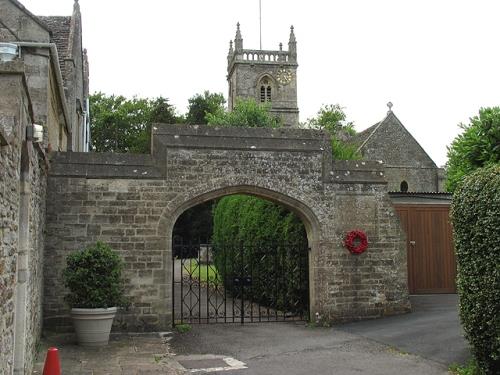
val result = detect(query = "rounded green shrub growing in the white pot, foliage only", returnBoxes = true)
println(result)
[63,241,125,309]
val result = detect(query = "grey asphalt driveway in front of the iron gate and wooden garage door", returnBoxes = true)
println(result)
[171,296,467,375]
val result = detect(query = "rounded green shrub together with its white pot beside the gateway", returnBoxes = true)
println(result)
[63,241,124,346]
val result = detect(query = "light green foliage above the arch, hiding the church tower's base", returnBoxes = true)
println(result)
[206,99,281,128]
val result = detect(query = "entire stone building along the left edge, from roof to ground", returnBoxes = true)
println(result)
[0,0,90,374]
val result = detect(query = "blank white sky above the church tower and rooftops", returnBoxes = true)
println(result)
[21,0,500,165]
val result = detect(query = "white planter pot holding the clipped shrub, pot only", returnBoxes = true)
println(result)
[71,307,116,346]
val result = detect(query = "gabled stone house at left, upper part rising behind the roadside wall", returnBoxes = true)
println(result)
[0,0,90,151]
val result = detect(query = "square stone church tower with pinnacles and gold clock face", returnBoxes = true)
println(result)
[227,23,299,126]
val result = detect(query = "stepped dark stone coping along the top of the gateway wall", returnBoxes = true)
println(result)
[50,124,394,184]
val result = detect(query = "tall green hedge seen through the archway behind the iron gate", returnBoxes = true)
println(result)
[212,195,309,313]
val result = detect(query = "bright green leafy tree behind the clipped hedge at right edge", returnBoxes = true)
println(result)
[446,107,500,192]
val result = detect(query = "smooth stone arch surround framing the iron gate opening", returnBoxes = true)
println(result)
[158,185,321,319]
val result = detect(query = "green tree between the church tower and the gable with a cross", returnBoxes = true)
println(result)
[306,104,361,160]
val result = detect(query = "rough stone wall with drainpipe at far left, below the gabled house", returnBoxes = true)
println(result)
[0,62,47,374]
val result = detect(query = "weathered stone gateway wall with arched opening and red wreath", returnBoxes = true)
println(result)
[44,126,409,330]
